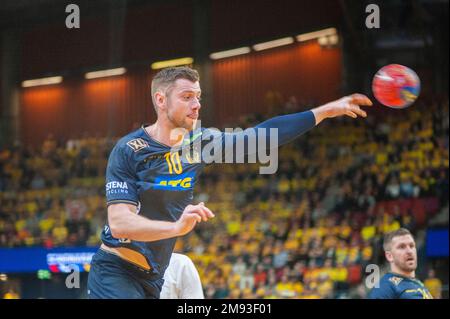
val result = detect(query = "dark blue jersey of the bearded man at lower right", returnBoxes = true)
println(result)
[369,273,433,299]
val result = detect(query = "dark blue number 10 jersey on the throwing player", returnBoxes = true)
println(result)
[102,111,315,277]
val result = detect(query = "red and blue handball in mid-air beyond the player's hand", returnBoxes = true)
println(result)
[372,64,420,109]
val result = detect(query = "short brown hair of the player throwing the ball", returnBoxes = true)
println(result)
[152,66,200,111]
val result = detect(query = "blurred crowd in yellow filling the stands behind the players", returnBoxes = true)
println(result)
[0,98,449,298]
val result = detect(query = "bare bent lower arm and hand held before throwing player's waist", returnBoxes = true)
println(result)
[108,203,214,241]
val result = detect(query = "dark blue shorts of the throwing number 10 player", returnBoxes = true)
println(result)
[87,249,164,299]
